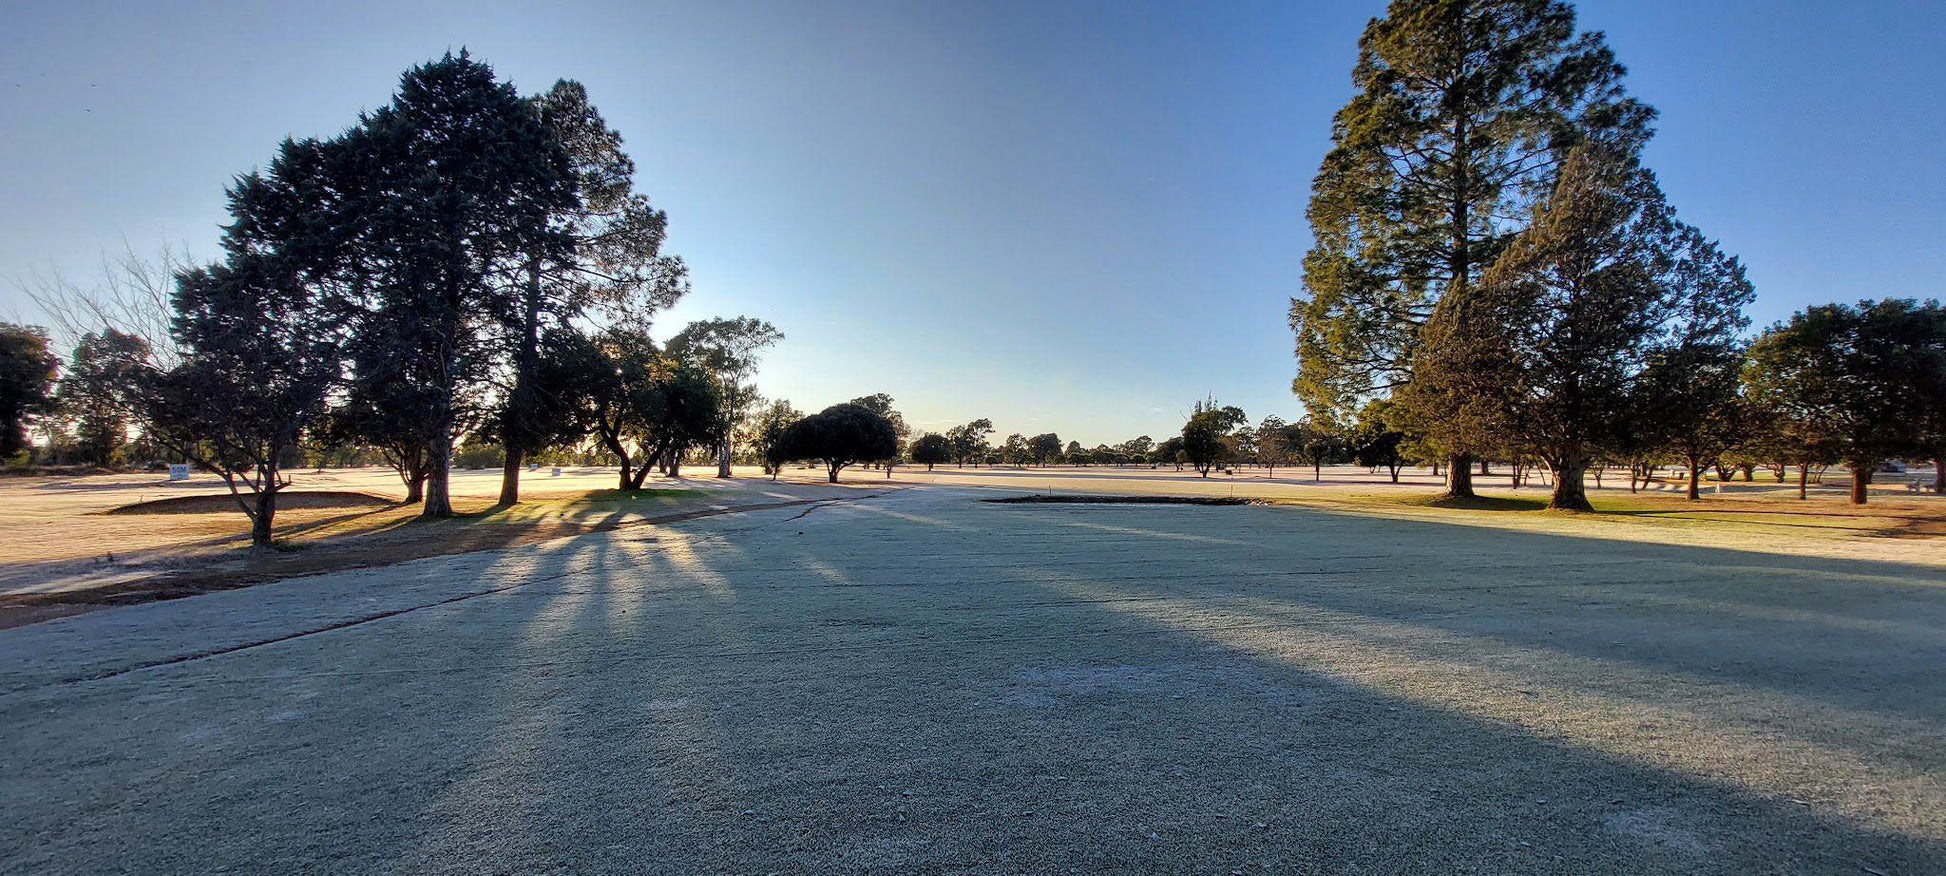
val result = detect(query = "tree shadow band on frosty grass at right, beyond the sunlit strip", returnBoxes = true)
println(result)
[1011,508,1946,722]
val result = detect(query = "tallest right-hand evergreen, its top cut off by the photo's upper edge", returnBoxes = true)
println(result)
[1290,0,1654,496]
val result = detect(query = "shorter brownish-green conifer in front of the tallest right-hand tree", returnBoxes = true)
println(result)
[1399,148,1751,510]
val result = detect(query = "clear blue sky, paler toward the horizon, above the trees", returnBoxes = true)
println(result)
[0,0,1946,444]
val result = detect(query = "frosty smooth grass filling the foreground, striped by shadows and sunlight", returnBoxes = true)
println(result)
[15,500,1946,872]
